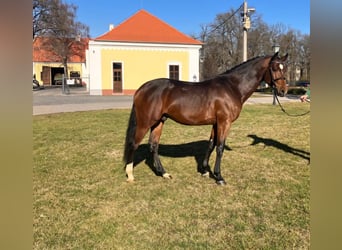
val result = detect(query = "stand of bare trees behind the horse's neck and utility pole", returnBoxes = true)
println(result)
[199,10,310,82]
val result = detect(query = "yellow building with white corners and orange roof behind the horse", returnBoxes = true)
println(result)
[87,10,202,95]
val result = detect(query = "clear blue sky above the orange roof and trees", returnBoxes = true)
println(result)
[63,0,310,38]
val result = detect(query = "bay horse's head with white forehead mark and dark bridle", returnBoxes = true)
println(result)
[264,52,288,96]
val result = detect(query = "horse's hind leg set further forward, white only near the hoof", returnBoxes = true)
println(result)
[149,121,172,179]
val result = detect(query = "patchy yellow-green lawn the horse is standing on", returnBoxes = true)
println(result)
[33,103,310,249]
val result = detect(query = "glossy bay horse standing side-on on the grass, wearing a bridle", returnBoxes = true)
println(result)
[124,52,288,185]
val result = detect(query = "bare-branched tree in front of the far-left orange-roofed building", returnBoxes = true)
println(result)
[32,0,89,85]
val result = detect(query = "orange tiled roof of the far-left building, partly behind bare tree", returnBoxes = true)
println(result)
[32,37,89,63]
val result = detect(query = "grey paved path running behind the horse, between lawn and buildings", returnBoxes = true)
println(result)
[32,88,299,115]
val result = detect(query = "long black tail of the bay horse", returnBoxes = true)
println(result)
[123,103,137,164]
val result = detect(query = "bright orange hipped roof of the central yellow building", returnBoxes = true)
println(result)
[95,10,202,45]
